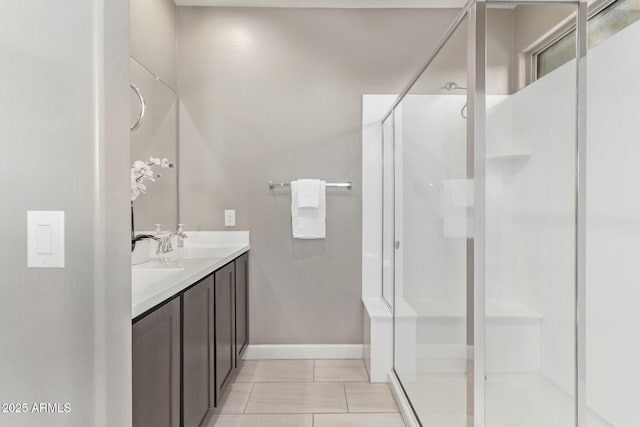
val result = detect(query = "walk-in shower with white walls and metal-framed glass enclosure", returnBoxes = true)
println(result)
[365,0,640,427]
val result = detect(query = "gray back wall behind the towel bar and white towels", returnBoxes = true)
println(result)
[177,7,455,344]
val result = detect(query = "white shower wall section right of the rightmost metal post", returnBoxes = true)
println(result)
[587,23,640,427]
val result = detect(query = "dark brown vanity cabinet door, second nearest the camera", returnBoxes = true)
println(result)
[182,275,215,427]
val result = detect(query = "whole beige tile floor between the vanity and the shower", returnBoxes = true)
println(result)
[208,360,404,427]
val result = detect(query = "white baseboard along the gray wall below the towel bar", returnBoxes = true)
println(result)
[242,344,364,360]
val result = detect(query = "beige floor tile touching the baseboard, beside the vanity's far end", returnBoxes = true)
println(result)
[235,360,313,383]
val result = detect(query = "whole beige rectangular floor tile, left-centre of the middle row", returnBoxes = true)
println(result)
[245,383,347,414]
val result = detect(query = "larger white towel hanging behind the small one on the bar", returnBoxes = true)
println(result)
[291,181,327,239]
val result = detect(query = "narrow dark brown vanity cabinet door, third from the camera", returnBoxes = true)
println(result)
[215,262,235,403]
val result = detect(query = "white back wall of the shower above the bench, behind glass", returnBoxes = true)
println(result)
[388,95,516,310]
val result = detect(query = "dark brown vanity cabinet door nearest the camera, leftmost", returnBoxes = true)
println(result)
[132,298,180,427]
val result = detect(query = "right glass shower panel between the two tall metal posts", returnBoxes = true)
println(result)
[476,3,577,427]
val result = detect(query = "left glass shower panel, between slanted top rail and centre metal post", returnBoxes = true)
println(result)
[385,11,473,427]
